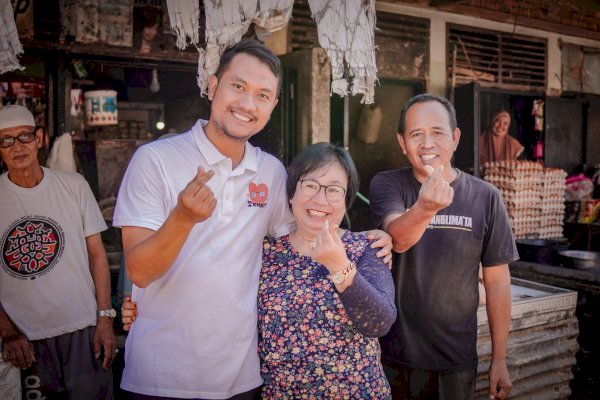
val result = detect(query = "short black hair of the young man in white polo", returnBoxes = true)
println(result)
[215,39,283,97]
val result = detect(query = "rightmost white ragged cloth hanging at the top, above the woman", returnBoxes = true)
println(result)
[308,0,377,104]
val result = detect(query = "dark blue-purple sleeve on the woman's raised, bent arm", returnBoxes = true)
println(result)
[340,244,396,337]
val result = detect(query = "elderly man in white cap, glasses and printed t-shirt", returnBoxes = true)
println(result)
[0,105,115,399]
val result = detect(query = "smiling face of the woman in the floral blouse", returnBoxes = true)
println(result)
[290,162,348,237]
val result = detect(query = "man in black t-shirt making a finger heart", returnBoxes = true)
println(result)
[370,94,518,399]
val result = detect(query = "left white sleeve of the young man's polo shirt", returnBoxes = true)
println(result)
[113,146,168,231]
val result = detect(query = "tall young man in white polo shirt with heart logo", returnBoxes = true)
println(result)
[113,40,392,400]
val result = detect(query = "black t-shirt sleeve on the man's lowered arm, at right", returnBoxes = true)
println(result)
[481,188,519,267]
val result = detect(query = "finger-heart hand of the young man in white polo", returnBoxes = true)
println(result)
[175,167,217,223]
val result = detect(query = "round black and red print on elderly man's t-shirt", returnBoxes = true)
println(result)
[1,216,65,279]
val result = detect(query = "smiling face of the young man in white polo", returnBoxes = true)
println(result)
[208,53,279,141]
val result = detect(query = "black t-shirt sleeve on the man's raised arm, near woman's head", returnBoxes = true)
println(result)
[369,171,406,228]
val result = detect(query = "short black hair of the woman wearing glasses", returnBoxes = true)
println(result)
[287,142,359,208]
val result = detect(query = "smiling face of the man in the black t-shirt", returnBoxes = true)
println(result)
[398,101,460,182]
